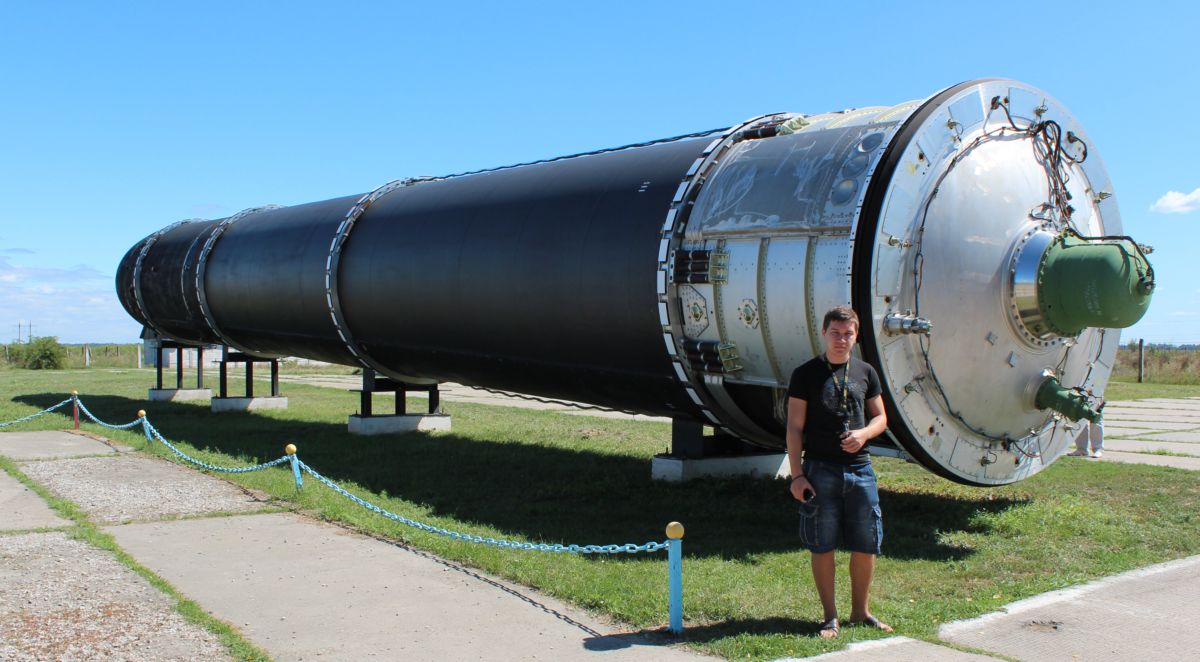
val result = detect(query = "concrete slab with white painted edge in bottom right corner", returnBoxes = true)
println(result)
[938,556,1200,662]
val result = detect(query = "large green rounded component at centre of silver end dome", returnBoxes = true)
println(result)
[1038,235,1154,336]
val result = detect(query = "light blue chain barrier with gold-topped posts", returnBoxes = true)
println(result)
[0,395,683,634]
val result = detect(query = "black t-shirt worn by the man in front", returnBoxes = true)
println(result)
[787,356,883,464]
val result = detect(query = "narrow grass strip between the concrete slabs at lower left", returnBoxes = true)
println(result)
[0,453,270,662]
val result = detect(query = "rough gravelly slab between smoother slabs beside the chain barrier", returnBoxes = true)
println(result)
[22,455,266,523]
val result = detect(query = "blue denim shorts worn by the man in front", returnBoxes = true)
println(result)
[800,459,883,554]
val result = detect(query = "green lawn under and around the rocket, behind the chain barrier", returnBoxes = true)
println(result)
[0,371,1200,660]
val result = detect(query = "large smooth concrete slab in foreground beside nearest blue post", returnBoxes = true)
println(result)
[107,513,704,661]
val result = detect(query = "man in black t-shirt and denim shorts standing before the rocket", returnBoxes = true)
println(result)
[787,306,892,638]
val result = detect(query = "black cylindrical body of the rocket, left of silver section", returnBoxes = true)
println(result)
[118,140,709,416]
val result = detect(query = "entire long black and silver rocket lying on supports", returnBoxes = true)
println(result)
[116,79,1154,486]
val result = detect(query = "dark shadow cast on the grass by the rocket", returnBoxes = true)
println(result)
[14,393,1019,561]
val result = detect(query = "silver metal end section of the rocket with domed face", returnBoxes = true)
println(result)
[660,80,1121,485]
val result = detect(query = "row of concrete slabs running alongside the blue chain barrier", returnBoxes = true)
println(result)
[0,432,708,661]
